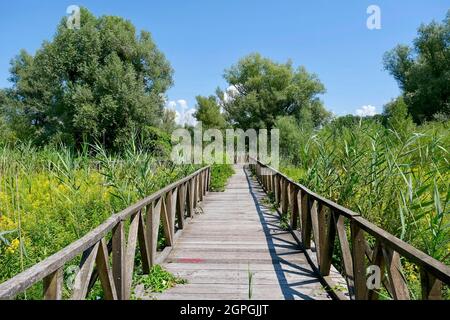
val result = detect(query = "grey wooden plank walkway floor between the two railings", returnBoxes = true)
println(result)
[154,166,330,300]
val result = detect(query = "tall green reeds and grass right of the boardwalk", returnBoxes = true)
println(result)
[281,121,450,297]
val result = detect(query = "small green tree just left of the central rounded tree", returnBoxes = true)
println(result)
[194,96,227,129]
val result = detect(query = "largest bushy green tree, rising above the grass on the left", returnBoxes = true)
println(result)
[1,8,173,147]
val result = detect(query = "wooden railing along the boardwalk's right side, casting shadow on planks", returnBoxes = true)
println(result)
[250,160,450,300]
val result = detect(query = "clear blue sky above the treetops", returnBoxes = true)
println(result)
[0,0,450,119]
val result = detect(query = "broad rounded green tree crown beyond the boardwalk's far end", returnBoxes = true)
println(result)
[218,54,330,129]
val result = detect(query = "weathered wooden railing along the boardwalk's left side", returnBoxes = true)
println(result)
[0,167,211,300]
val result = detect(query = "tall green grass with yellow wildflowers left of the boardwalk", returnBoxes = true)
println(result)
[0,144,198,299]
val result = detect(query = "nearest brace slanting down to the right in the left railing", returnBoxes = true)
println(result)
[95,239,117,300]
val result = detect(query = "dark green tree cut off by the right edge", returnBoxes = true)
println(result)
[384,11,450,123]
